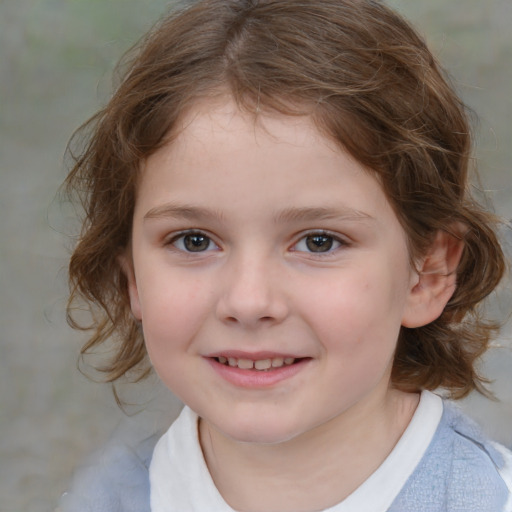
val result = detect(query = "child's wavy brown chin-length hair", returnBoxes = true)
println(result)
[65,0,505,398]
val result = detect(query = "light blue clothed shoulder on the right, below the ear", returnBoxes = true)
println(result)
[392,402,512,512]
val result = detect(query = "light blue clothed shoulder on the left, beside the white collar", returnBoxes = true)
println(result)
[57,433,161,512]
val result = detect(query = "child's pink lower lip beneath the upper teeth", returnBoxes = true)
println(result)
[206,357,311,389]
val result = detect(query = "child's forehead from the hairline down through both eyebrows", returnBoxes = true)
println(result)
[136,100,404,238]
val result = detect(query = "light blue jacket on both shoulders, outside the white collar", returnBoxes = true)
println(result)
[58,403,509,512]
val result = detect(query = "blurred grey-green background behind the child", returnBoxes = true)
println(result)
[0,0,512,512]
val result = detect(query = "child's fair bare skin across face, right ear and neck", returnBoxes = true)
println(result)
[122,98,460,512]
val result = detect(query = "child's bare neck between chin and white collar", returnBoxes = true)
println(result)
[200,391,418,512]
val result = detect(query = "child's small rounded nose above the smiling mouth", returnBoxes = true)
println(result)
[216,251,289,329]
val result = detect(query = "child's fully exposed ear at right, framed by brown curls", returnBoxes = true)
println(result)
[402,229,464,328]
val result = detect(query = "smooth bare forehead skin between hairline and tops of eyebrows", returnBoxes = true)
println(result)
[142,96,373,199]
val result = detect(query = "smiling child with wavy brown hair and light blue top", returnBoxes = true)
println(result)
[62,0,512,512]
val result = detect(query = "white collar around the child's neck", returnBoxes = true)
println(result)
[149,391,443,512]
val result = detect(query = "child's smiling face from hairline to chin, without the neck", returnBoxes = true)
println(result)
[126,100,417,443]
